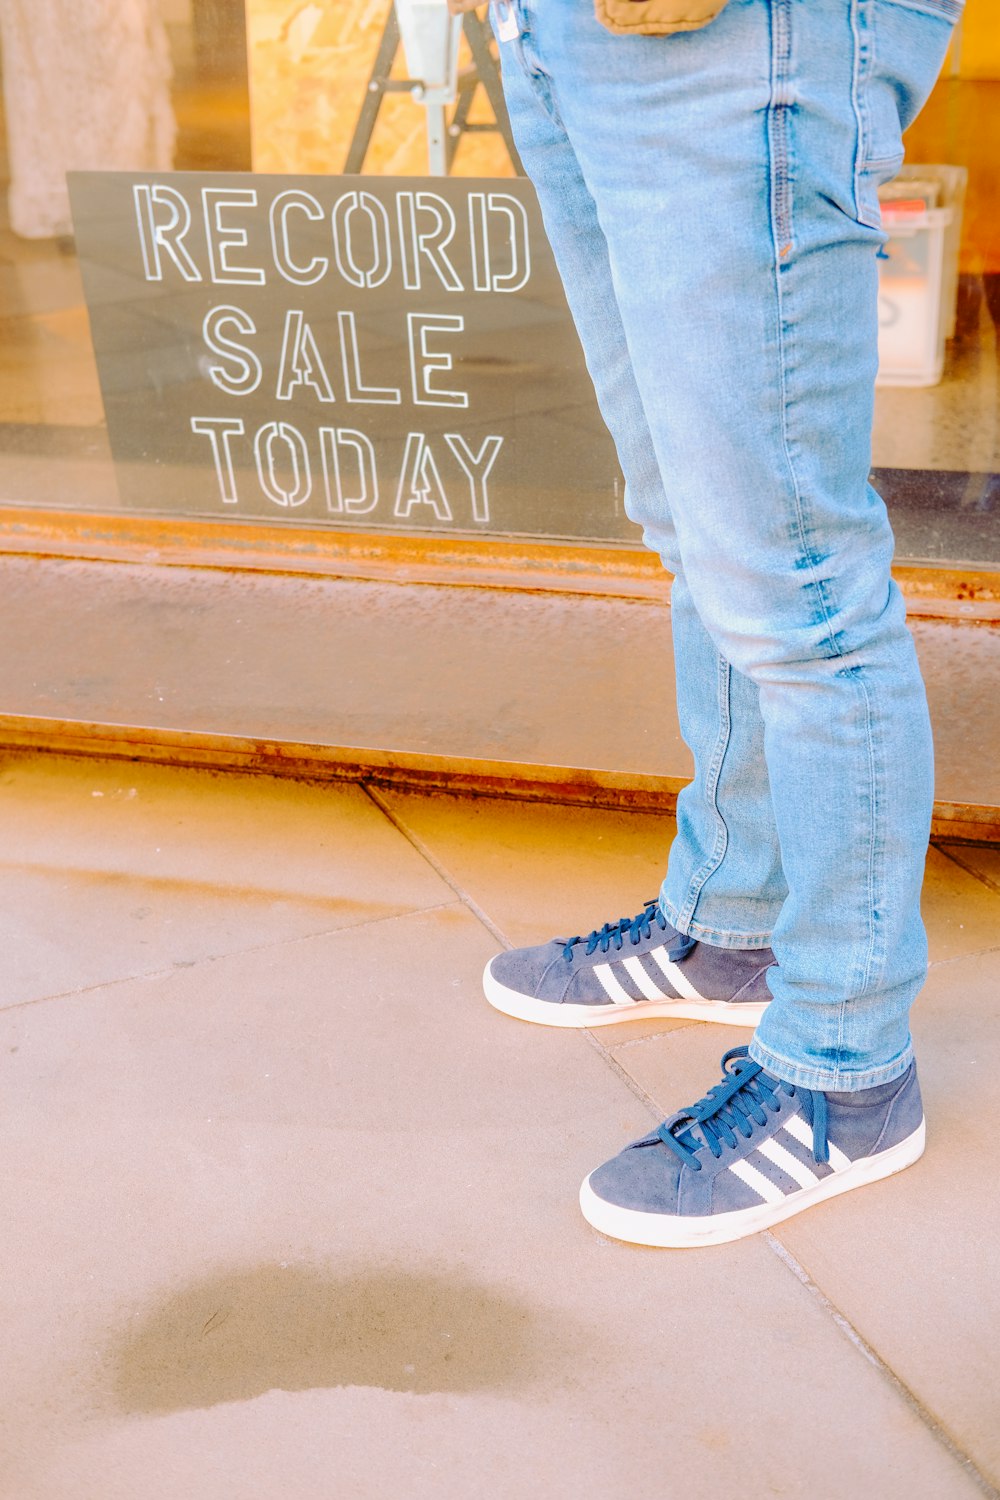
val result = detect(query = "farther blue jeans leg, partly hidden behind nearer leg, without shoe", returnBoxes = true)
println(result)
[485,14,787,950]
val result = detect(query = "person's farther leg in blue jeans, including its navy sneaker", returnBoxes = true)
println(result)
[483,17,787,1026]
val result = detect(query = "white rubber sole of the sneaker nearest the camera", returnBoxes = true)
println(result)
[580,1121,925,1250]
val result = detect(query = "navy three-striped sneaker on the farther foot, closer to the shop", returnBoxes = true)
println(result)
[483,902,775,1026]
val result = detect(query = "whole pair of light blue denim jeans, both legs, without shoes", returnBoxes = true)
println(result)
[501,0,960,1089]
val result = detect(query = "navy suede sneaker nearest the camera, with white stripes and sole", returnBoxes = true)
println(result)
[580,1047,924,1248]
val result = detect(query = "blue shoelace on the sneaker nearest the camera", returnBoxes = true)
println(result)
[657,1047,829,1172]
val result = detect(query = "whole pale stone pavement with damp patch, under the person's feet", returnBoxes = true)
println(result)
[0,756,1000,1500]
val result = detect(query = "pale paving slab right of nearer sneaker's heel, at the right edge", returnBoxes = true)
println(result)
[778,954,1000,1488]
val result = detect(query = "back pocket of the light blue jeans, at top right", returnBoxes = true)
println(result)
[852,0,963,230]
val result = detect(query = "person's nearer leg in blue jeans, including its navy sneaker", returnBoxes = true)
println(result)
[491,0,960,1247]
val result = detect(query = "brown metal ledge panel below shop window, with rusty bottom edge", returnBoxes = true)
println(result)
[0,555,1000,842]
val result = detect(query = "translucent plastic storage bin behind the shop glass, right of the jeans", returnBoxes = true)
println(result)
[876,162,969,386]
